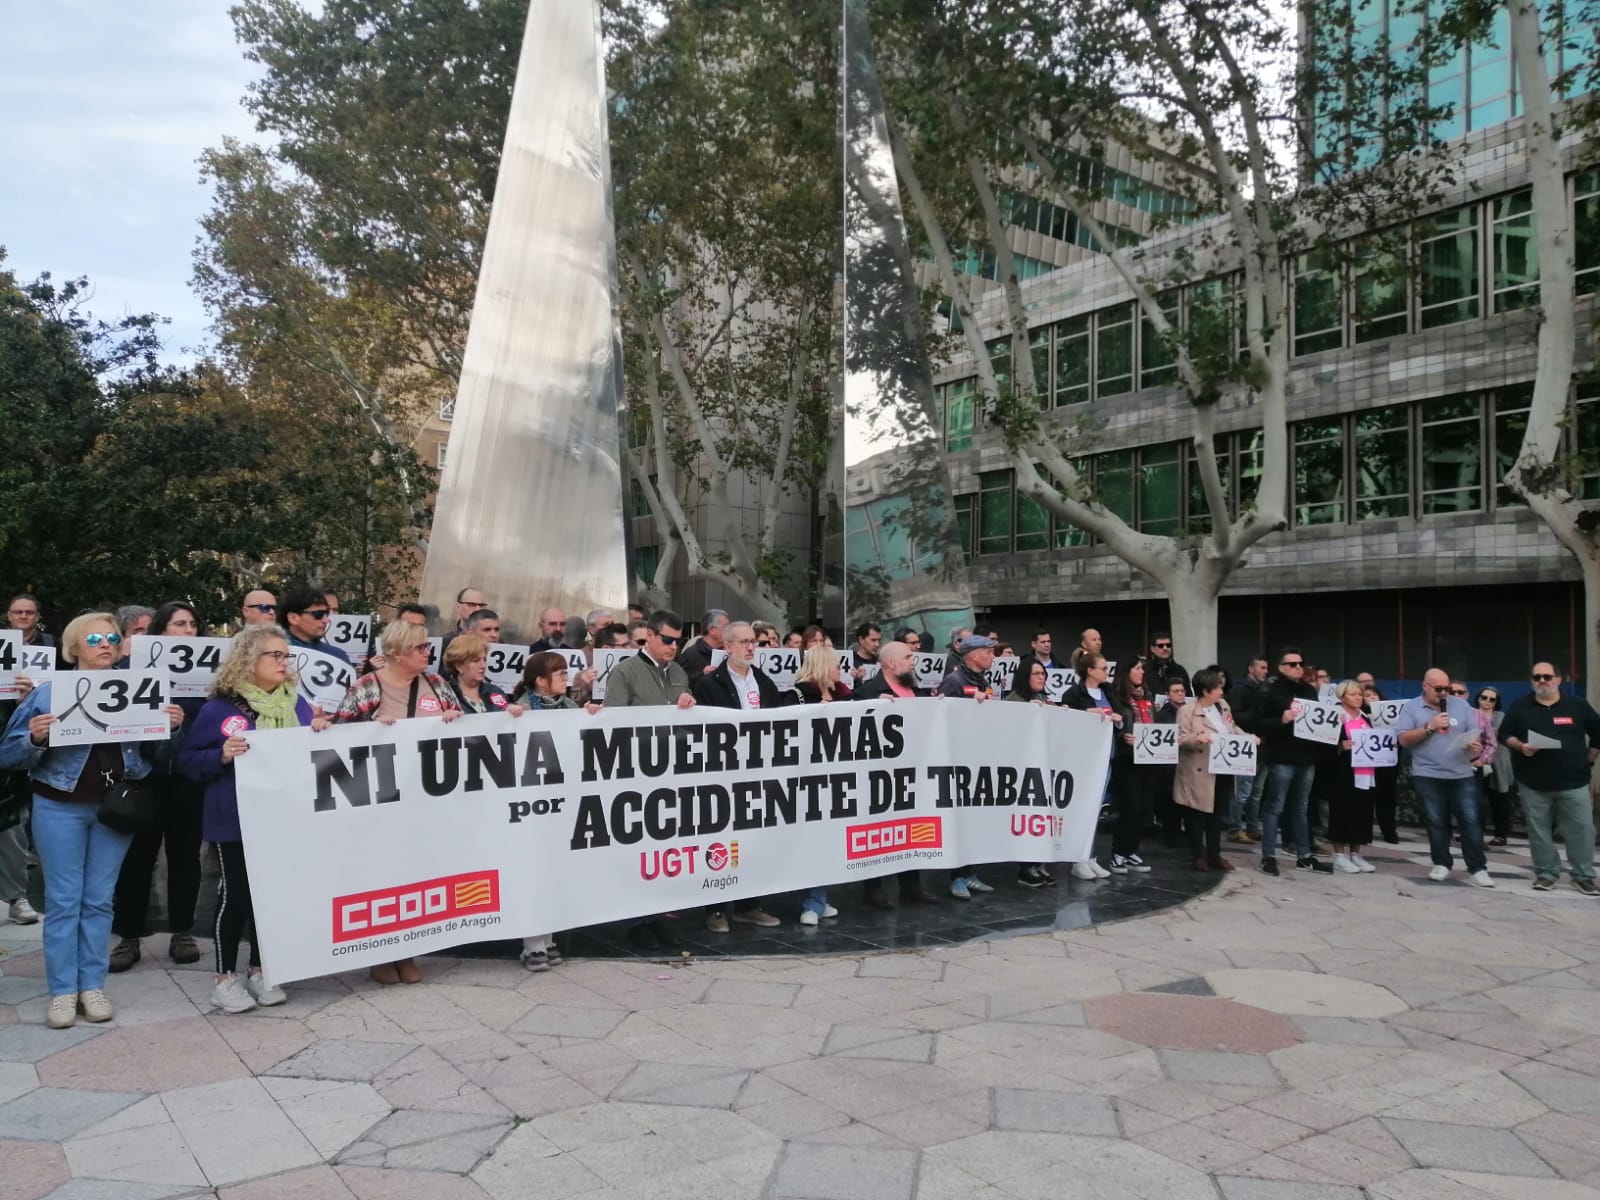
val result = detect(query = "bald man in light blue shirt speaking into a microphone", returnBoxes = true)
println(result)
[1395,667,1494,888]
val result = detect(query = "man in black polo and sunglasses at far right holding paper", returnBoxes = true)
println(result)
[1501,662,1600,899]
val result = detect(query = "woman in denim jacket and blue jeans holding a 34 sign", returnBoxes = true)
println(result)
[0,613,184,1029]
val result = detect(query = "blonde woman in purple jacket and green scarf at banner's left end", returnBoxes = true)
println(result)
[178,626,330,1013]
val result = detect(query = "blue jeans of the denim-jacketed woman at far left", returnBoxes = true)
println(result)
[34,795,133,995]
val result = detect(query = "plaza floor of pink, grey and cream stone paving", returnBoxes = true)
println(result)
[0,842,1600,1200]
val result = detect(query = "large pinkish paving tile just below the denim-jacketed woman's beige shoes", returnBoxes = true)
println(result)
[38,1016,250,1093]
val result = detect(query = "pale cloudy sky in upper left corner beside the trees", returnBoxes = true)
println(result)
[0,0,259,362]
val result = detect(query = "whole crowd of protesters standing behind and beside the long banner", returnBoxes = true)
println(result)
[0,587,1600,1029]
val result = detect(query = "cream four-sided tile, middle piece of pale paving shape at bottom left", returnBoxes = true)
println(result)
[162,1078,322,1186]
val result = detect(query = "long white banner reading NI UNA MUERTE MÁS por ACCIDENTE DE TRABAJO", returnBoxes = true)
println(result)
[235,699,1110,982]
